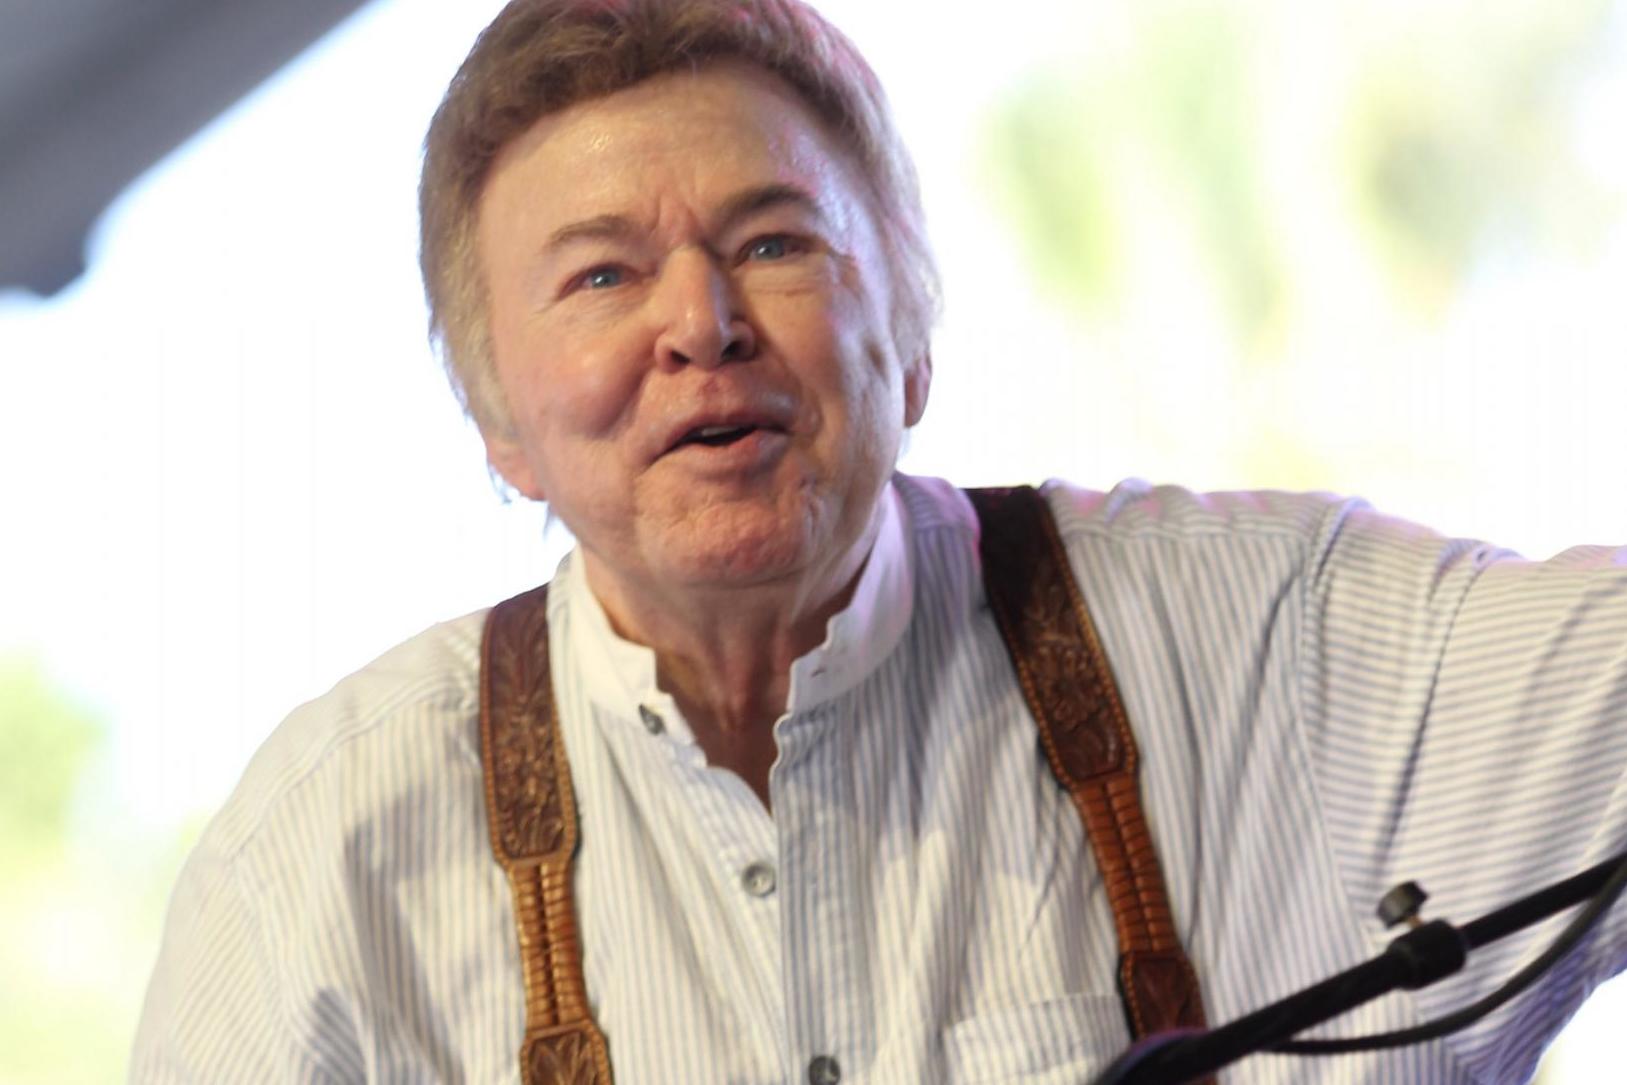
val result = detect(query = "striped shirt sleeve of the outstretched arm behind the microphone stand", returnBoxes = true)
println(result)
[1300,506,1627,1080]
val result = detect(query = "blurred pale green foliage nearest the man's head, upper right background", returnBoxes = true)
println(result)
[989,3,1282,346]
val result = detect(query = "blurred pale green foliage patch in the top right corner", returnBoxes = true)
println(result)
[1349,0,1614,299]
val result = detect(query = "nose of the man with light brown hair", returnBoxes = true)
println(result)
[654,249,757,368]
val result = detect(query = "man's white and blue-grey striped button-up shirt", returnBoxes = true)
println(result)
[132,477,1627,1085]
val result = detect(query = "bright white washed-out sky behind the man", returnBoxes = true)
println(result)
[0,0,1627,1080]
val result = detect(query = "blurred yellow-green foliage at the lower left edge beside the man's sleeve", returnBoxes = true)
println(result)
[0,657,197,1085]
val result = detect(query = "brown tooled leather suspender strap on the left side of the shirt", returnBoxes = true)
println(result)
[480,584,610,1085]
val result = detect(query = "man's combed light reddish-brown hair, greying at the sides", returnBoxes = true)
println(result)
[418,0,939,434]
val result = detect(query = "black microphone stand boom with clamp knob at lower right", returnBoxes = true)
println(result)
[1093,852,1627,1085]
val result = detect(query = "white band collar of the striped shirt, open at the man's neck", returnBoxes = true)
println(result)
[553,485,914,739]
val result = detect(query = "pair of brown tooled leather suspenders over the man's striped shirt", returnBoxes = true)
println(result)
[480,486,1204,1085]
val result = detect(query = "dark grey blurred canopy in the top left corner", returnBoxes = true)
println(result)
[0,0,364,294]
